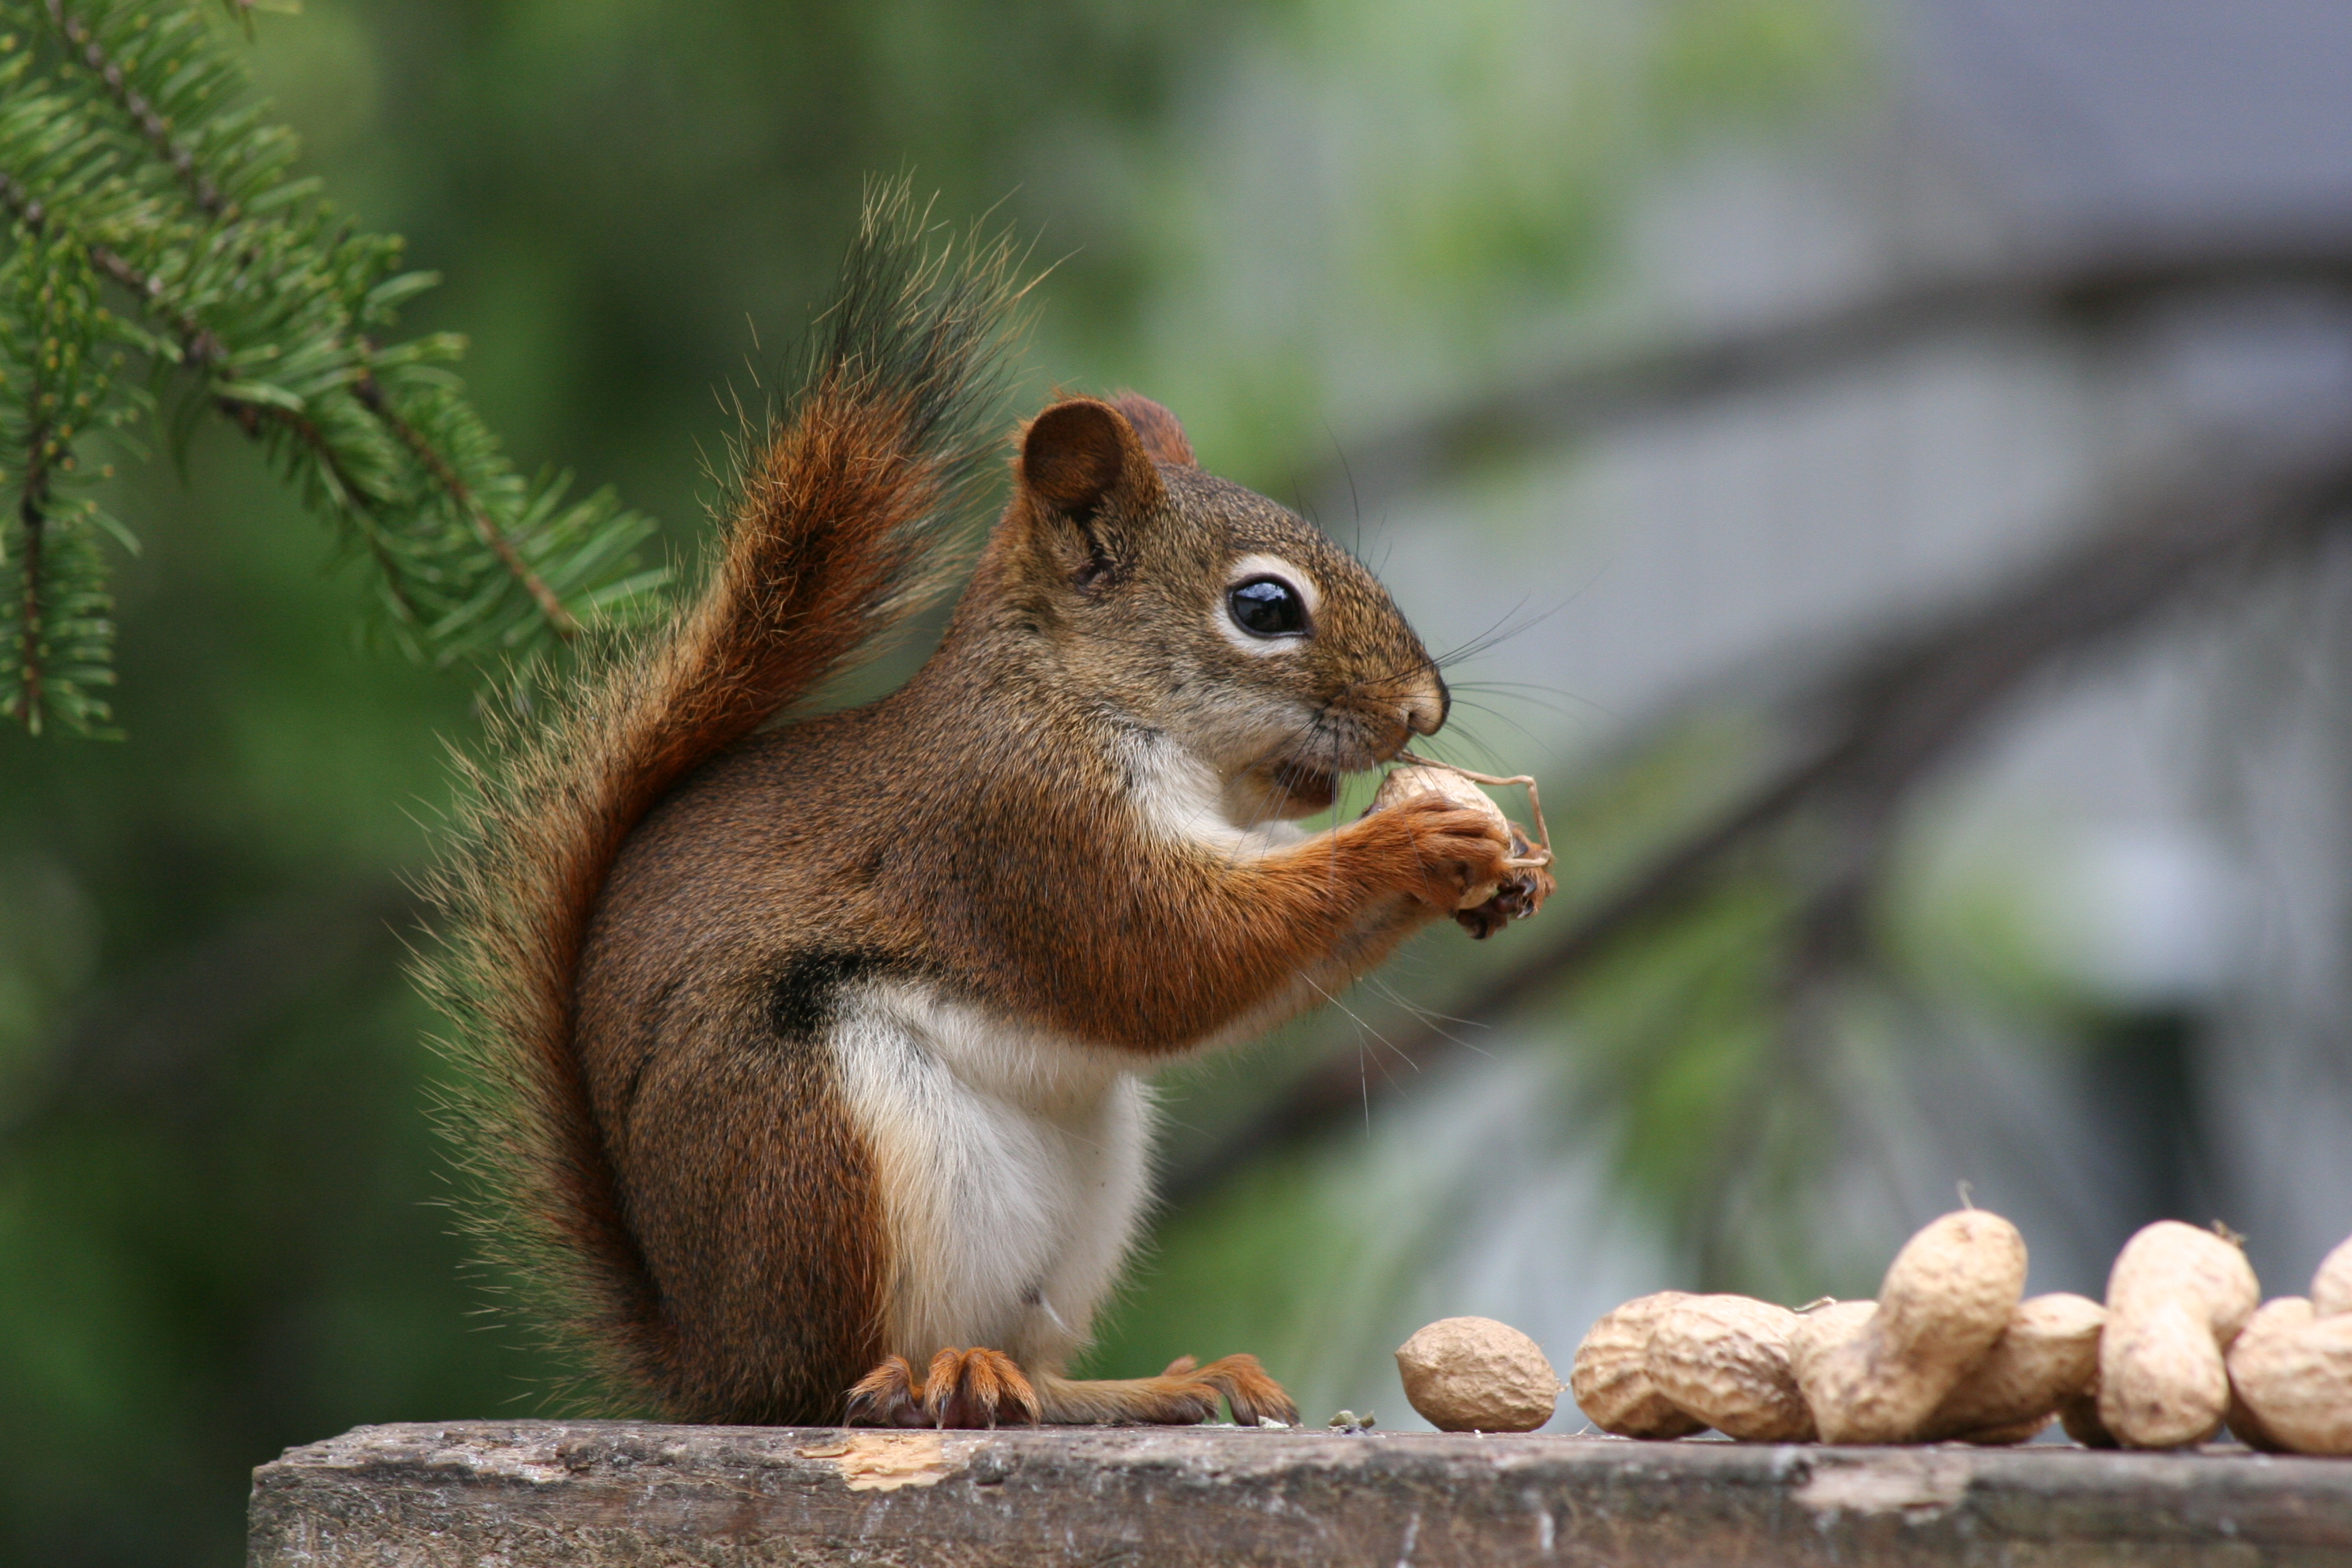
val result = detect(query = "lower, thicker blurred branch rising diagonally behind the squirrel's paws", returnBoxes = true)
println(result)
[1171,416,2352,1201]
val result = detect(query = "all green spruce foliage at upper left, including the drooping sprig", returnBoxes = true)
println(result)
[0,0,659,734]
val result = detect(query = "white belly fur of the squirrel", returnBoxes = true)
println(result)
[828,983,1150,1375]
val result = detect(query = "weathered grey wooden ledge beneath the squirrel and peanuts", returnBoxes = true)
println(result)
[249,1422,2352,1568]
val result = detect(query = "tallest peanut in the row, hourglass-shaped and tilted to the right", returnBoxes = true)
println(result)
[1804,1208,2025,1443]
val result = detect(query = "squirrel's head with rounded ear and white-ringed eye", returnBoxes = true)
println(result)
[990,393,1449,821]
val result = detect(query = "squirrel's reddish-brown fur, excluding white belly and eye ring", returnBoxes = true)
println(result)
[430,190,1510,1424]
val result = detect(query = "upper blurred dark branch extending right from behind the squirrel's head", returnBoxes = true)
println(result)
[1301,235,2352,512]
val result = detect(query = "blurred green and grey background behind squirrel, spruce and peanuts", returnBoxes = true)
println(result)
[0,0,2352,1566]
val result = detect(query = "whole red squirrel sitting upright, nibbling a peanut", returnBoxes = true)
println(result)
[423,193,1548,1427]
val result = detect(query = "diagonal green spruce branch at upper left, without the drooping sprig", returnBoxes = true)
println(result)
[0,0,661,724]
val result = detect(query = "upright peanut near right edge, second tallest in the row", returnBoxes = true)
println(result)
[2098,1220,2260,1448]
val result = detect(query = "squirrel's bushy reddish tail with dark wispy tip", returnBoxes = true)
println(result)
[419,183,1021,1392]
